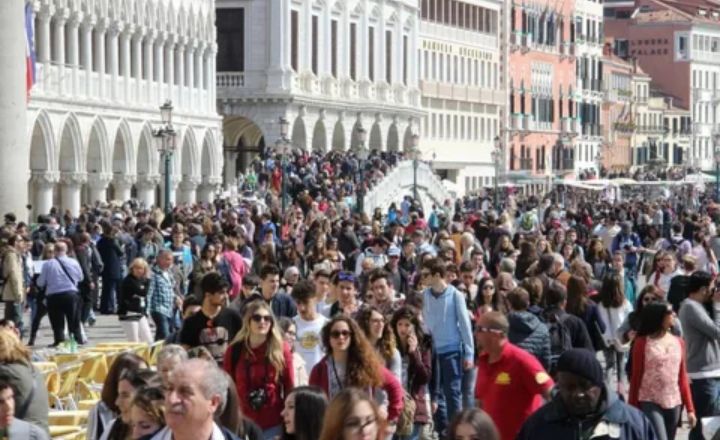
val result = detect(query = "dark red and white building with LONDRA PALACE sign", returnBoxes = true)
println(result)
[605,0,720,169]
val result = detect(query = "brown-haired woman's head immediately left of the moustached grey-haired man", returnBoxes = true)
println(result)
[130,386,165,440]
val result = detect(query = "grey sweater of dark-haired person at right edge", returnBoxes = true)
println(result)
[678,298,720,379]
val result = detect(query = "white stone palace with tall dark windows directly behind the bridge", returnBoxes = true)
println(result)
[217,0,423,185]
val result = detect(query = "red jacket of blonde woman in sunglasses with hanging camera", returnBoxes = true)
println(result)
[223,342,295,430]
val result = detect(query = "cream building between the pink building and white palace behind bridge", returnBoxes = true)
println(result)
[418,0,507,191]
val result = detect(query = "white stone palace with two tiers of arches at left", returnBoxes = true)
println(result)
[27,0,223,218]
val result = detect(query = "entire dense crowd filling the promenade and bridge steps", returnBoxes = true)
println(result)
[0,149,720,440]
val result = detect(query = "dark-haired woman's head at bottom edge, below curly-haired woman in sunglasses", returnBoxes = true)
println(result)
[280,386,328,440]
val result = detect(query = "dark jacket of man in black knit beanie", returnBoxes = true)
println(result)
[517,387,657,440]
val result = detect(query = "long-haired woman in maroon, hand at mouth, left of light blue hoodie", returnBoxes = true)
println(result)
[390,306,432,440]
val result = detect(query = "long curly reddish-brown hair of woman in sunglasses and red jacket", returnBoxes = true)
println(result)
[322,315,383,388]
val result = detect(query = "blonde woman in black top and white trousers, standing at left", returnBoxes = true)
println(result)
[118,258,154,344]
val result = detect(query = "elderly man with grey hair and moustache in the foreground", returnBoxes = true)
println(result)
[152,359,237,440]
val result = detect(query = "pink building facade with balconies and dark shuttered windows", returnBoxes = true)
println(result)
[507,0,580,183]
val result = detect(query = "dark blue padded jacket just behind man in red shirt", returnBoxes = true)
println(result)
[508,311,550,370]
